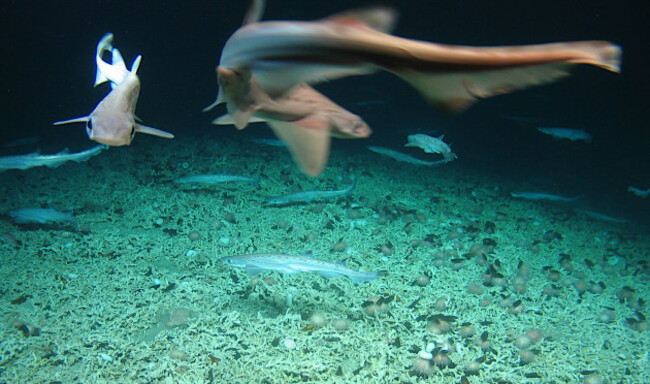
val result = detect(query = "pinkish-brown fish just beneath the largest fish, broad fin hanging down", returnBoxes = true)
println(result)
[212,67,372,177]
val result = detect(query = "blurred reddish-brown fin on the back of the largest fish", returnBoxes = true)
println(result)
[322,6,399,33]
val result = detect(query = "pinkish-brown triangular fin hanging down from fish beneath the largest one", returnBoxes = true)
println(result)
[267,117,330,177]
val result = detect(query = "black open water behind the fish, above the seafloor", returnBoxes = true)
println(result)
[0,0,650,222]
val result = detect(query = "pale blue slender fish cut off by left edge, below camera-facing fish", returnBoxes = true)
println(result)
[0,145,108,172]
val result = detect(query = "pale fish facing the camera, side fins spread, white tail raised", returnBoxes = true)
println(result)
[54,33,174,146]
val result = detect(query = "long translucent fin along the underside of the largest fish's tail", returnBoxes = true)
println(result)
[396,62,572,113]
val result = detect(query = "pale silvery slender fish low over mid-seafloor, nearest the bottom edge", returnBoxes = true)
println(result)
[220,253,387,284]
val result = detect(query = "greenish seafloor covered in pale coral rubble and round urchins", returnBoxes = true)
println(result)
[0,130,650,384]
